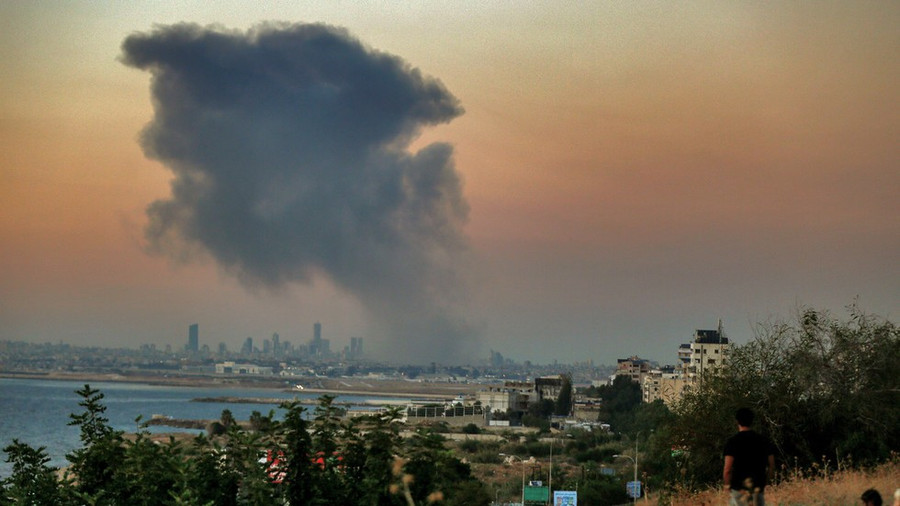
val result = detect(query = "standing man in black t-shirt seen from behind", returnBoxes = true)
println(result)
[722,408,775,506]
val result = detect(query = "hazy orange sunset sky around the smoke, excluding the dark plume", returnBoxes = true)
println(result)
[0,1,900,363]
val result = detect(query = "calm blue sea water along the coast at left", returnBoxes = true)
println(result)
[0,378,405,480]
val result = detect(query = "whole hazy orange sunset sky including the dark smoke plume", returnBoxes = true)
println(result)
[0,1,900,364]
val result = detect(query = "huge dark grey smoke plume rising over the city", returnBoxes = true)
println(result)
[122,24,482,361]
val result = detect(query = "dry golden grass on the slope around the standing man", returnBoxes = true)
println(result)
[645,459,900,506]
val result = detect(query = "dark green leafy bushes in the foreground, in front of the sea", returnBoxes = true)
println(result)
[0,385,497,506]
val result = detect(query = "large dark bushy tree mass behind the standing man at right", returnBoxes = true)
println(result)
[669,305,900,485]
